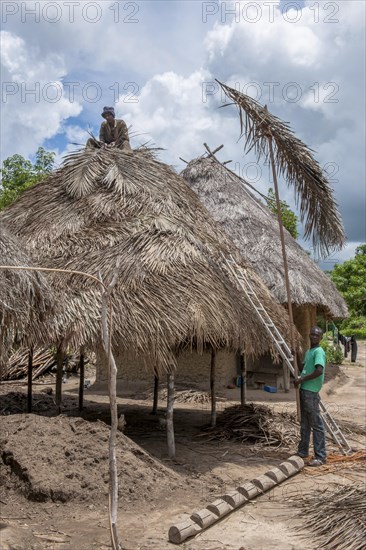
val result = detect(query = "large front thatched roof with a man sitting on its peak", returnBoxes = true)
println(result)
[1,149,300,374]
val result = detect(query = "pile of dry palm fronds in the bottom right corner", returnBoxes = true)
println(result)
[301,483,366,550]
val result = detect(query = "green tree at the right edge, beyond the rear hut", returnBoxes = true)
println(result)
[330,244,366,317]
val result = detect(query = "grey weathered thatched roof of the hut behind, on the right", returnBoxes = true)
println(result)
[181,157,348,318]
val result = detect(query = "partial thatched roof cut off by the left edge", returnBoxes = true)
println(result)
[0,224,54,368]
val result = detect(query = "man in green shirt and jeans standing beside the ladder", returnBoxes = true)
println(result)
[294,327,327,466]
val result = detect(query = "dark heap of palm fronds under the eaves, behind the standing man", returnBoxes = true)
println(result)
[205,403,299,447]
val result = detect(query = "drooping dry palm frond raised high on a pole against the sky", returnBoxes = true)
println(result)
[217,81,345,255]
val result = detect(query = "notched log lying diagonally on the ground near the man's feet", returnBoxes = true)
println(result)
[168,456,304,544]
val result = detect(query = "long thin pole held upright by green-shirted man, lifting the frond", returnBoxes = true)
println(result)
[268,134,301,420]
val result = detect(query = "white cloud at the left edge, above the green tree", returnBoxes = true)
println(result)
[1,31,82,158]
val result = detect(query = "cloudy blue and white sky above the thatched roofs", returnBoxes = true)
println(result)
[1,0,366,269]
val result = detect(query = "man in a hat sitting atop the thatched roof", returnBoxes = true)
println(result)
[86,107,132,151]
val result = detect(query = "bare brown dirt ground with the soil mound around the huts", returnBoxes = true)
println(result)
[0,342,366,550]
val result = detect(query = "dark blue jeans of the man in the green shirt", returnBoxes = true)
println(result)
[298,389,327,463]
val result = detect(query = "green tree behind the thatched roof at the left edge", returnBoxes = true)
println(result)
[0,147,55,210]
